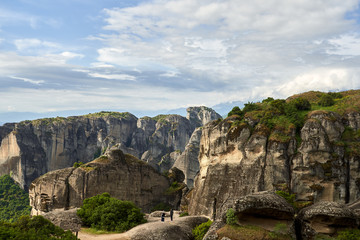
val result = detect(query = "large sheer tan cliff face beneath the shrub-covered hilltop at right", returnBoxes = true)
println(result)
[189,111,360,216]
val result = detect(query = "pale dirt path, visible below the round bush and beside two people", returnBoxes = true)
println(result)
[78,211,179,240]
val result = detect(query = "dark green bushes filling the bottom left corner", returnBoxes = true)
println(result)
[0,216,77,240]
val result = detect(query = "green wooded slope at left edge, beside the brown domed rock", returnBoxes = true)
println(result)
[0,175,31,222]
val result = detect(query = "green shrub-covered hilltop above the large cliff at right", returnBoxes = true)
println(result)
[227,90,360,142]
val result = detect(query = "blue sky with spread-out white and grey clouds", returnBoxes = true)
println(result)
[0,0,360,123]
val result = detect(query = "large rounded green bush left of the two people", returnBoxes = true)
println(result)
[77,193,146,232]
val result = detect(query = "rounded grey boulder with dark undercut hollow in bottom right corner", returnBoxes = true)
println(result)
[295,201,358,239]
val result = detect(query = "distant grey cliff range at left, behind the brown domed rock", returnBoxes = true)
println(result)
[0,107,220,189]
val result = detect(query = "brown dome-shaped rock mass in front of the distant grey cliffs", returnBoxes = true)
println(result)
[29,147,177,214]
